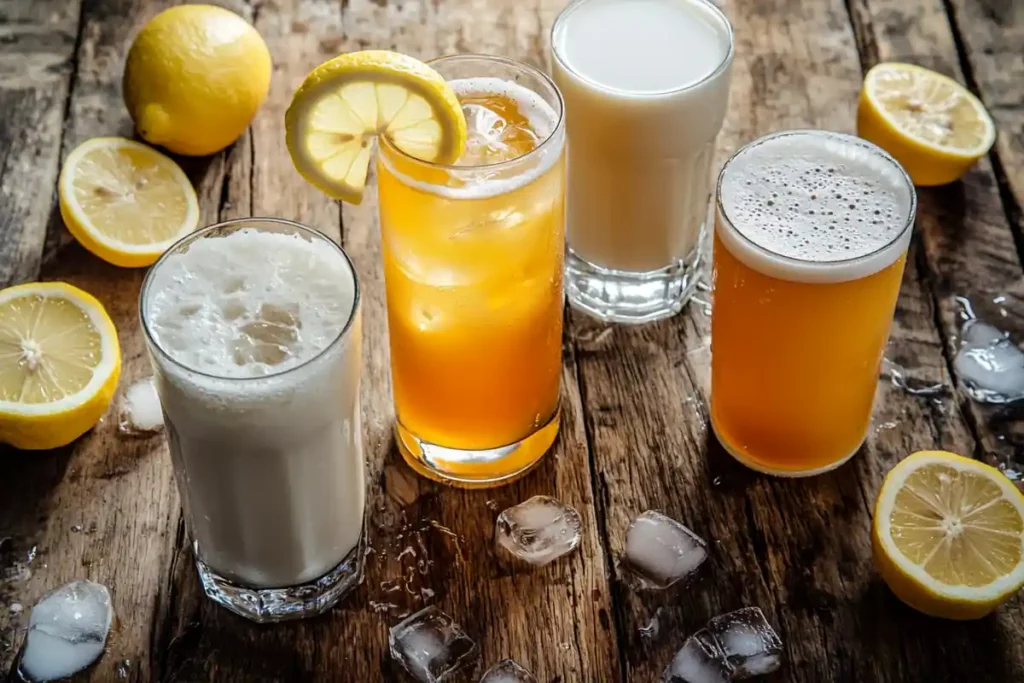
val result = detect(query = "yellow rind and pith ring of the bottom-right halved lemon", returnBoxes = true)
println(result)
[874,453,1024,603]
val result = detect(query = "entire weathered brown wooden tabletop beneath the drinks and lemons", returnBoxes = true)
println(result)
[0,0,1024,683]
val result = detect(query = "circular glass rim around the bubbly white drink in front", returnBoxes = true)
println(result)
[138,216,361,383]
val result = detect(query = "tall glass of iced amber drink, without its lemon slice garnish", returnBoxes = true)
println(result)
[378,55,565,486]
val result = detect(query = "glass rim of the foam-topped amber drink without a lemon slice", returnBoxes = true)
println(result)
[715,128,918,269]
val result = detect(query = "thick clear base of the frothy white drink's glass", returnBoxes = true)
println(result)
[193,533,366,624]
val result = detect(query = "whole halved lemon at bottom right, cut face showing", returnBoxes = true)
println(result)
[871,451,1024,620]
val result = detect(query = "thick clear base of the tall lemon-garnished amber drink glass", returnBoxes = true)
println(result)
[394,409,560,488]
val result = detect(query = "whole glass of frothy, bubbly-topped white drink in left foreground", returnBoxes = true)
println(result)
[139,218,366,622]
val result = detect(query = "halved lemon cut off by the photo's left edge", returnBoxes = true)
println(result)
[0,283,121,450]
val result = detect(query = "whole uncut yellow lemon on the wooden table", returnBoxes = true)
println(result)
[123,5,271,157]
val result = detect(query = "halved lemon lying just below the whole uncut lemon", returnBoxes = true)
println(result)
[58,137,199,267]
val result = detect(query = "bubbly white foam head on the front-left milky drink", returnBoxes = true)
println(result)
[141,224,359,422]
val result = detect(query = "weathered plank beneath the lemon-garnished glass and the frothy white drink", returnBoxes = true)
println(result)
[153,0,617,682]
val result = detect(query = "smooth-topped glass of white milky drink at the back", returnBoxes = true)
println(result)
[551,0,733,323]
